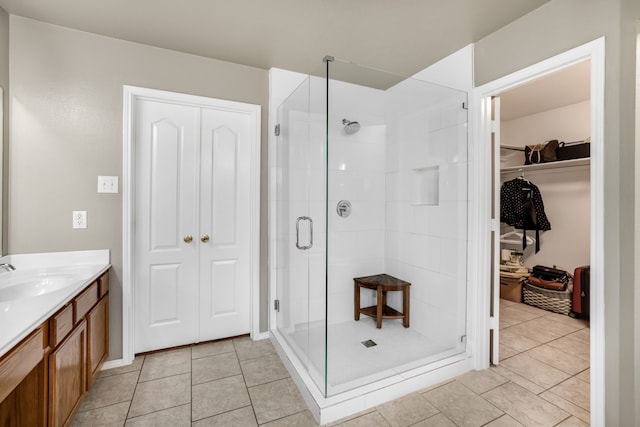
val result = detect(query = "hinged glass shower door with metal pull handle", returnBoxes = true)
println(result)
[276,77,326,393]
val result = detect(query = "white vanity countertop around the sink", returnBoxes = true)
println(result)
[0,249,111,357]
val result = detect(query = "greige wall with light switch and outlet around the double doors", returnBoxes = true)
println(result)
[11,15,268,359]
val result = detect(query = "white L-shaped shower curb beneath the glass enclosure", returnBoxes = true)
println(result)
[270,330,473,425]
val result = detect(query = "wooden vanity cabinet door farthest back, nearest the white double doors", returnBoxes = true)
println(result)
[87,295,109,390]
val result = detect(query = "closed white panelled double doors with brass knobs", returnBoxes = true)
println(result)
[134,99,256,353]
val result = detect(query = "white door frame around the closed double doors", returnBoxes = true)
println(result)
[122,85,261,365]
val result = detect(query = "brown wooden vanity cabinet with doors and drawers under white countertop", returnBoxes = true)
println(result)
[0,272,109,427]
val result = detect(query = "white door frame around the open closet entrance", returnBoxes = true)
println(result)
[470,37,605,425]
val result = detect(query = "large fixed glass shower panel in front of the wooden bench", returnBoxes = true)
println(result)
[326,60,469,396]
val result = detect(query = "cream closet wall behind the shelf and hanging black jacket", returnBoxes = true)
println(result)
[500,101,591,273]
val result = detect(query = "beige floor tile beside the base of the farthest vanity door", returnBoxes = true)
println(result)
[80,372,139,411]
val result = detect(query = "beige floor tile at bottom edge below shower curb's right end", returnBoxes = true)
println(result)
[424,382,503,427]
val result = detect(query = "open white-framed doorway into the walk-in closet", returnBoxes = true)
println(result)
[476,39,604,425]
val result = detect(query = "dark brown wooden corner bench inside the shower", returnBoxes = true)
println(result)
[353,274,411,329]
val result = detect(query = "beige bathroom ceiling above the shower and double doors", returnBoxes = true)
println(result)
[0,0,549,76]
